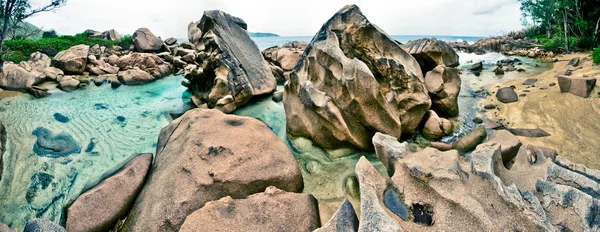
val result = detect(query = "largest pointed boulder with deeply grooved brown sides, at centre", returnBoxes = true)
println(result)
[283,5,431,149]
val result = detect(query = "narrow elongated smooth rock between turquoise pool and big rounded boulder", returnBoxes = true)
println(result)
[66,154,152,232]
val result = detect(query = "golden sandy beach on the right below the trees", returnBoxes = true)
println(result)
[485,53,600,169]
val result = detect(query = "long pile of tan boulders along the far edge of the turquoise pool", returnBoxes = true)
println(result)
[0,28,196,97]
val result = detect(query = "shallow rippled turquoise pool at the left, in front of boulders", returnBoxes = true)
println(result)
[0,76,186,229]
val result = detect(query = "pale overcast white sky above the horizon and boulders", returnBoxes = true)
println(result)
[27,0,522,38]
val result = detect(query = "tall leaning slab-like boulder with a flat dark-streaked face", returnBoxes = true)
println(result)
[185,11,277,113]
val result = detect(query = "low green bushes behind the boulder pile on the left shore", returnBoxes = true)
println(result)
[2,32,133,63]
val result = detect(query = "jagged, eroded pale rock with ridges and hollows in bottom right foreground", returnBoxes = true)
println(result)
[364,131,600,231]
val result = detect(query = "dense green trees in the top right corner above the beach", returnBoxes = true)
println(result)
[519,0,600,52]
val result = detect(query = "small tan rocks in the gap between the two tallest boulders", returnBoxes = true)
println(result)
[261,41,308,85]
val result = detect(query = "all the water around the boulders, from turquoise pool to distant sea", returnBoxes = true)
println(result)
[0,36,543,229]
